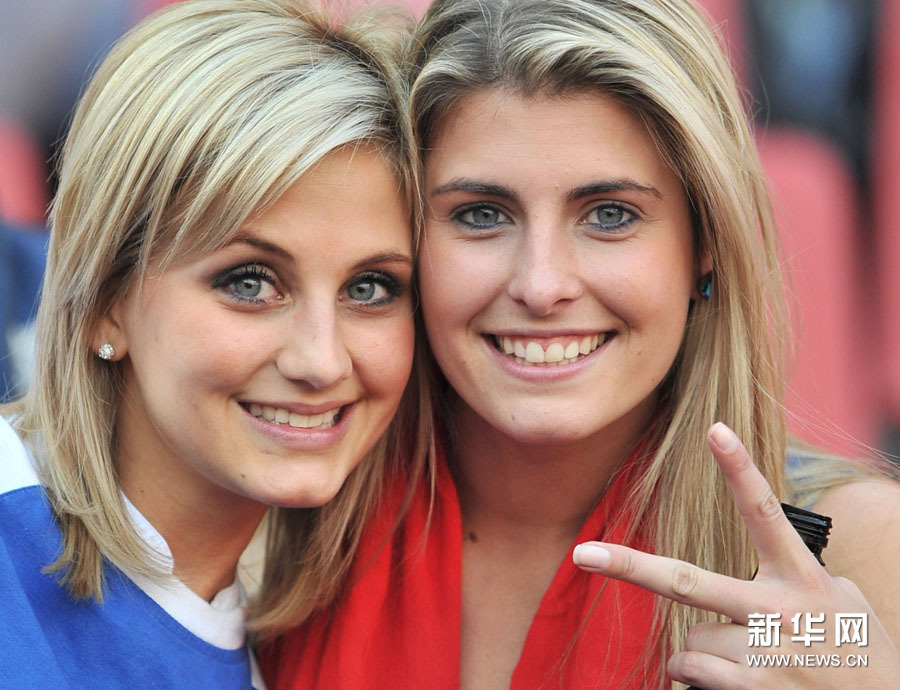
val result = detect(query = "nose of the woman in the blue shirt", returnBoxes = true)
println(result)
[276,301,353,390]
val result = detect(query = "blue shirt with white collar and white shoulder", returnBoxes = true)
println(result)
[0,418,259,690]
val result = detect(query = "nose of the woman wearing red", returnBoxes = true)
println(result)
[507,224,582,316]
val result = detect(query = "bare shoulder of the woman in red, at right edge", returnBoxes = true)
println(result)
[814,477,900,644]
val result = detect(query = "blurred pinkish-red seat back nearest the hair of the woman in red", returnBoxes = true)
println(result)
[758,130,878,456]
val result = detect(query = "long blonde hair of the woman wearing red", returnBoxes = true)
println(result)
[408,0,786,682]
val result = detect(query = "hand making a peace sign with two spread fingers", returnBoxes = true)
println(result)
[574,423,900,690]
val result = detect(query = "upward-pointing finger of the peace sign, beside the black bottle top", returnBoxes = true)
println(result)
[707,422,818,575]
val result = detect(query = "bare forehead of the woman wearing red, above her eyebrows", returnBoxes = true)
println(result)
[426,89,681,189]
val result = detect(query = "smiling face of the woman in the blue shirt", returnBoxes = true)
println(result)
[101,149,413,506]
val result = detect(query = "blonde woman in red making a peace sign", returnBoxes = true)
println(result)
[263,0,900,690]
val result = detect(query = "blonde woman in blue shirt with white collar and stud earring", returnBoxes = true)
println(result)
[0,0,431,690]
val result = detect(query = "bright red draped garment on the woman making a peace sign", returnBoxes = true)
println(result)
[260,444,655,690]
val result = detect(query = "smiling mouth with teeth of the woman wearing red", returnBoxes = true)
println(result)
[484,331,616,380]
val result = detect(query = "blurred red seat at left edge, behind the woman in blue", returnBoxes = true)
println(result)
[0,116,49,226]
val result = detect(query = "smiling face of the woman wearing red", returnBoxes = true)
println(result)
[420,90,699,443]
